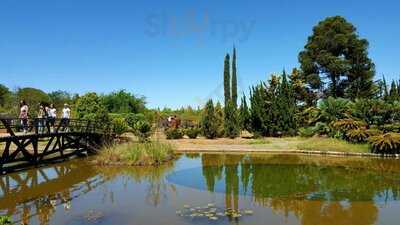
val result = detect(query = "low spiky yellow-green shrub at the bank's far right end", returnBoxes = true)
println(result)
[369,133,400,154]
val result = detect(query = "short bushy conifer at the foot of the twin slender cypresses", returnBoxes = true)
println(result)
[224,100,240,138]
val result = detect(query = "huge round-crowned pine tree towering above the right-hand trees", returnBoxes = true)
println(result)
[298,16,375,99]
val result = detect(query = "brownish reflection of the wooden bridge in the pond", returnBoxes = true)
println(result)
[0,161,99,225]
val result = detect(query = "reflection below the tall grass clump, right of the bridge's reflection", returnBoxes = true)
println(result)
[97,162,175,206]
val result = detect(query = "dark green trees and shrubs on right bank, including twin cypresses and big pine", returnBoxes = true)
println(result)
[201,16,400,153]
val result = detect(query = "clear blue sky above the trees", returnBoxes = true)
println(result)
[0,0,400,108]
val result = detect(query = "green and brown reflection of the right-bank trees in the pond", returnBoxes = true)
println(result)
[202,154,400,225]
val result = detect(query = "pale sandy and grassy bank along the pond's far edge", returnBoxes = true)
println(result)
[162,137,400,159]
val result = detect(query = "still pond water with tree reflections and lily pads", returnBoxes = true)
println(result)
[0,154,400,225]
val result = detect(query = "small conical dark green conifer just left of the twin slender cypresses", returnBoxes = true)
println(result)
[201,99,217,139]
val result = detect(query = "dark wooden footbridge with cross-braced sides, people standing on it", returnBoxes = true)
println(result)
[0,118,111,174]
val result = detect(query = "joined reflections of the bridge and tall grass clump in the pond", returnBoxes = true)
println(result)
[0,160,174,225]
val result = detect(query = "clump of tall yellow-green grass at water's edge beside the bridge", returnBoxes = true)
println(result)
[93,141,174,166]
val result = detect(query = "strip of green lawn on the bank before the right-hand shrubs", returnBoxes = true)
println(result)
[296,138,370,153]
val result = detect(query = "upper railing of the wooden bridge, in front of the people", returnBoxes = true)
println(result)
[0,117,108,136]
